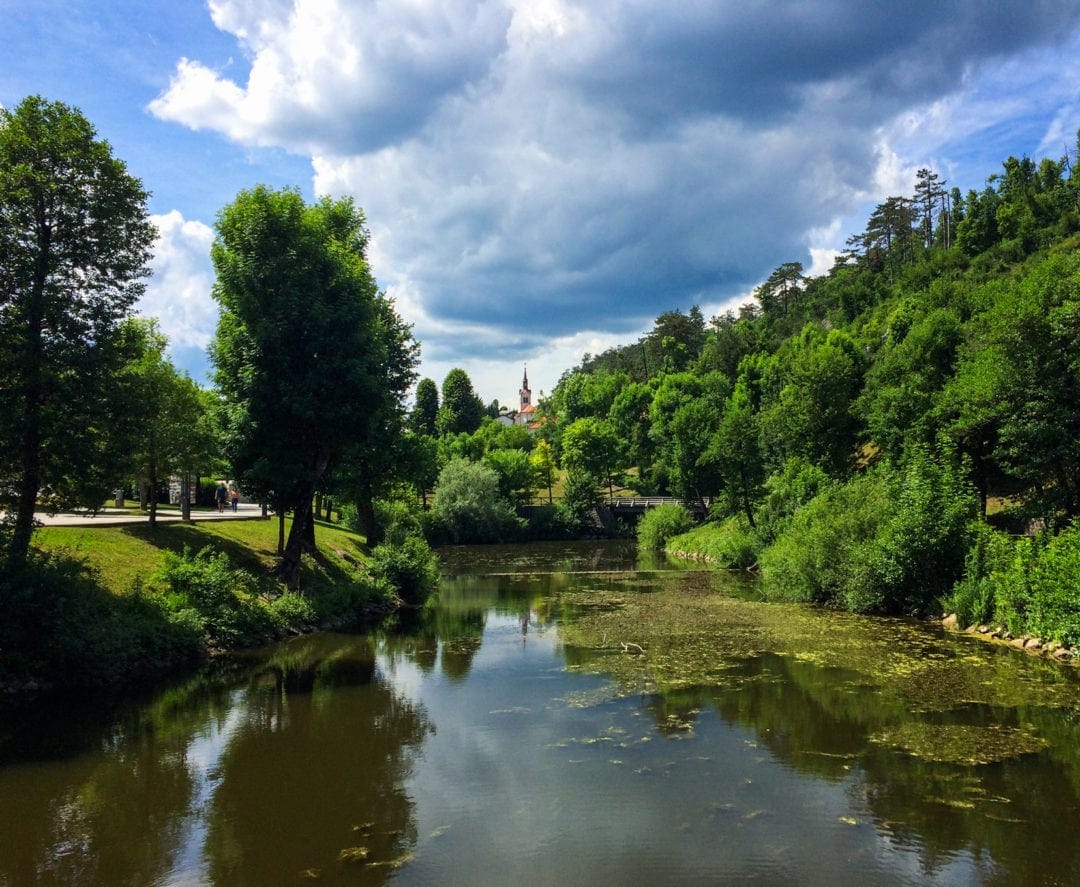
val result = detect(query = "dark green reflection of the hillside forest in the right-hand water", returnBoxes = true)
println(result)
[646,655,1080,884]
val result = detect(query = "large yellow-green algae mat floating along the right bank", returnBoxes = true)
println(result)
[555,570,1080,723]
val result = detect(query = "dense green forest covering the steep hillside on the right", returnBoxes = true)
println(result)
[505,140,1080,643]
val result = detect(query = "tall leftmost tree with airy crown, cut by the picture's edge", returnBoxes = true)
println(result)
[0,96,154,564]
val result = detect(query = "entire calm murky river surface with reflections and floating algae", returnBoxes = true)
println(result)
[0,535,1080,887]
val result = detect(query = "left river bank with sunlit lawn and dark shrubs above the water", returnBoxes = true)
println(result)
[0,521,396,689]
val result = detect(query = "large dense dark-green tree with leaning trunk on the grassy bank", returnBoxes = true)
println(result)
[211,186,416,583]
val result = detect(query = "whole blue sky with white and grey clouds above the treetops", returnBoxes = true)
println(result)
[6,0,1080,405]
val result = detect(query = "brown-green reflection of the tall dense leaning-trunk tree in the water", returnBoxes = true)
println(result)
[204,636,430,884]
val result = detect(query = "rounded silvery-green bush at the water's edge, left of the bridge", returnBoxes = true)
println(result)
[433,458,521,543]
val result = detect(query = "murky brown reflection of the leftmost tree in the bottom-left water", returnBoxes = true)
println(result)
[0,678,236,885]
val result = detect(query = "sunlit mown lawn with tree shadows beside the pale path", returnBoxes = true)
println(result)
[33,519,367,593]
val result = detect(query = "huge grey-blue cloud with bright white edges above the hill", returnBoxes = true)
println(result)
[154,0,1080,373]
